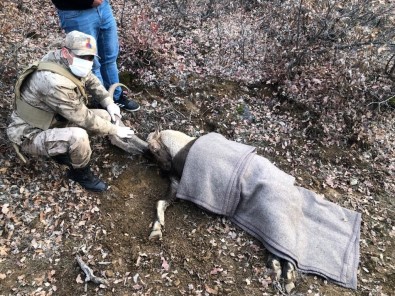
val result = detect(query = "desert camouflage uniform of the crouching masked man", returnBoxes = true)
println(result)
[7,50,117,168]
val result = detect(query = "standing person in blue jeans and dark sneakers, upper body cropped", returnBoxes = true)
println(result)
[52,0,140,112]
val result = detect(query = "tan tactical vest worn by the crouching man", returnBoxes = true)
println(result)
[14,61,87,130]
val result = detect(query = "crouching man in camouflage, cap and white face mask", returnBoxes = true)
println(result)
[7,31,138,192]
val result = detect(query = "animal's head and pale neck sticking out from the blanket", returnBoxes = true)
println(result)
[147,130,194,171]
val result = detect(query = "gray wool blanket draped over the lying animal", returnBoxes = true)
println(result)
[177,133,361,289]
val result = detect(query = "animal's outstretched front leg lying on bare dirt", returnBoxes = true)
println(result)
[149,178,178,240]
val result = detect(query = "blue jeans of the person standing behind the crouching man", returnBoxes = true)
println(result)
[58,0,122,101]
